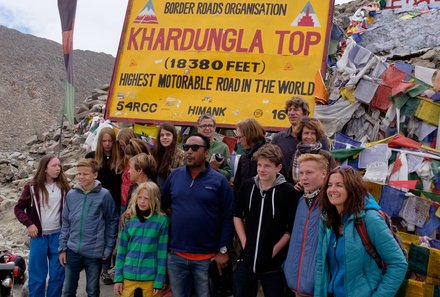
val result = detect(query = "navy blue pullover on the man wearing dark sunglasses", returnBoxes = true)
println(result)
[162,162,234,254]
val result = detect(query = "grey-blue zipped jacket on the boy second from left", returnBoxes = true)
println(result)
[58,181,119,258]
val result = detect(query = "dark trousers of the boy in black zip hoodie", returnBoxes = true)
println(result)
[234,260,286,297]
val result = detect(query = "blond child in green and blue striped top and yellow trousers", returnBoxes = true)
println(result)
[114,181,168,297]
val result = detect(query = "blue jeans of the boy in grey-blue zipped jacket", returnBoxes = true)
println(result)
[63,249,102,297]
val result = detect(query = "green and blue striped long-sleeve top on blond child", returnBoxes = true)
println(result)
[115,213,168,289]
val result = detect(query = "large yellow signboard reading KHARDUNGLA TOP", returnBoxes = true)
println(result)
[106,0,334,130]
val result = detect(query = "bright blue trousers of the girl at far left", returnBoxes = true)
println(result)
[29,232,64,297]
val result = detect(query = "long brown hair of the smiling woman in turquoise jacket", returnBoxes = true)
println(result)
[321,165,368,228]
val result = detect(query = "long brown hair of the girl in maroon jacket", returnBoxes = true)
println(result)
[33,155,70,205]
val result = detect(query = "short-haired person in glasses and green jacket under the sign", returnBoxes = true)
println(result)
[197,113,231,180]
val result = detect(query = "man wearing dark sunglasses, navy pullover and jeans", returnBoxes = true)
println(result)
[162,134,234,297]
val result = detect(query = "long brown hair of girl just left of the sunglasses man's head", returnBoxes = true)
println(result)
[153,124,177,179]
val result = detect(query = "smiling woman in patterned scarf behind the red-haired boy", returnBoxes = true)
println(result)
[290,118,336,190]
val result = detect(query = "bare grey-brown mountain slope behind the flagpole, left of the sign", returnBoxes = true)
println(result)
[0,26,115,151]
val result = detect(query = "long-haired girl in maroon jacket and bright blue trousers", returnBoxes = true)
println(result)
[14,155,70,296]
